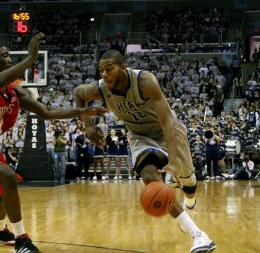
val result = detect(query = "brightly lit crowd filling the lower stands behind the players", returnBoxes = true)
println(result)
[0,51,260,181]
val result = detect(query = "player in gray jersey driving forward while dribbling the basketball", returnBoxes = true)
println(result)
[75,50,216,253]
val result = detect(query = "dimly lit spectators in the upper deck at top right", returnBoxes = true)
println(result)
[145,7,230,43]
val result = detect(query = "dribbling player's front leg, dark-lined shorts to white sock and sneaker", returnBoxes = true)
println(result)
[130,136,216,253]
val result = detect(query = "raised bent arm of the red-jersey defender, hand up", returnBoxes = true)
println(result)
[0,33,44,87]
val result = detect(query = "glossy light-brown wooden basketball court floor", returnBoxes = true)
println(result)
[0,181,260,253]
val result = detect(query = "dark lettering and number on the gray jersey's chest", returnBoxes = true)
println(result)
[117,99,147,121]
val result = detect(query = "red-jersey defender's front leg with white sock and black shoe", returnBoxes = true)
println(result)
[0,164,40,253]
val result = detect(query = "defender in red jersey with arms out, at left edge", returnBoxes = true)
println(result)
[0,33,107,253]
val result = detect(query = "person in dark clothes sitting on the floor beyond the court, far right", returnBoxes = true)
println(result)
[228,153,255,179]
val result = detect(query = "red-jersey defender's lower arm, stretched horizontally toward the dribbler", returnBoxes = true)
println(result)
[16,87,104,119]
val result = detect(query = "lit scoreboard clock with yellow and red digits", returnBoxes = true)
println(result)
[11,11,31,33]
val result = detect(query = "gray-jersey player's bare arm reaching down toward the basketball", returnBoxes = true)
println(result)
[140,72,177,173]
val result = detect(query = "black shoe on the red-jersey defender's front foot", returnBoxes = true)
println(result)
[15,234,41,253]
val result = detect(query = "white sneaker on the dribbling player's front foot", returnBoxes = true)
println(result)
[190,231,217,253]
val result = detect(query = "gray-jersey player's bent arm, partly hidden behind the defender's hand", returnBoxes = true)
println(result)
[74,83,107,145]
